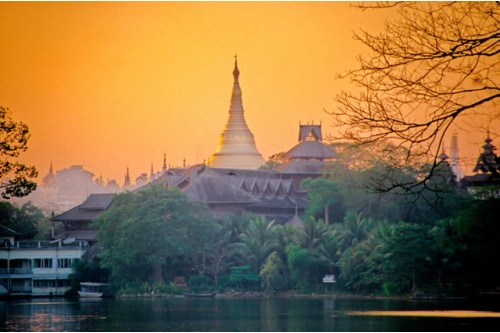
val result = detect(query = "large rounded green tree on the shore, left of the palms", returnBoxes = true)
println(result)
[93,186,214,286]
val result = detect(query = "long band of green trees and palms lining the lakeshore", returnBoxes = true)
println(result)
[76,145,500,295]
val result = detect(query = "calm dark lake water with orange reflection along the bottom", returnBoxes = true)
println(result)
[0,298,500,332]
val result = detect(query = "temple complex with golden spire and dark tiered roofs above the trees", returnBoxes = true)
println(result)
[54,59,336,246]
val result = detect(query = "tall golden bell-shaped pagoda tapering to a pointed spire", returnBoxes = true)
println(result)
[208,57,264,170]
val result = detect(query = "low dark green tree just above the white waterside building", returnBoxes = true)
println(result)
[0,201,47,239]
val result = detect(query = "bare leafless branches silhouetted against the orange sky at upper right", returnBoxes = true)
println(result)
[331,1,500,190]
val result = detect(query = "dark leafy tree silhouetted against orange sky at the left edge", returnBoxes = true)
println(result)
[0,106,38,199]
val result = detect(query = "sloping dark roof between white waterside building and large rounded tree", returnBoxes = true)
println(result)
[54,193,115,222]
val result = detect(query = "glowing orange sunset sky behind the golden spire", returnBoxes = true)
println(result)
[0,2,500,184]
